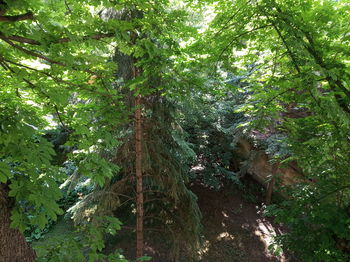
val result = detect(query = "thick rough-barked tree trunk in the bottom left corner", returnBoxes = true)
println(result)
[0,184,36,262]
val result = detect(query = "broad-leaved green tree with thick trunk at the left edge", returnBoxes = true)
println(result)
[0,0,122,261]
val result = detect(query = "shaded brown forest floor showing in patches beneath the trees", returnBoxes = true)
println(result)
[34,178,296,262]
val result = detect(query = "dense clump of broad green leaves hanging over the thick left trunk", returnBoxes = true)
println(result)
[0,89,61,231]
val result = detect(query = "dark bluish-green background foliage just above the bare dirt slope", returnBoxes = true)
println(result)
[180,90,239,189]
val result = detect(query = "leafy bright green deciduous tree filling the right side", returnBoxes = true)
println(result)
[208,0,350,261]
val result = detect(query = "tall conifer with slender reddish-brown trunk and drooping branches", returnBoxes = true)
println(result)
[67,1,200,257]
